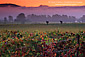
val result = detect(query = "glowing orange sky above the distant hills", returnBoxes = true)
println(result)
[0,0,85,7]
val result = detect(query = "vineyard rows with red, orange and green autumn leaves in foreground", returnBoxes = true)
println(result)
[0,30,85,57]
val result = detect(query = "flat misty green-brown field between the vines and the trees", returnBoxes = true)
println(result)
[0,23,85,32]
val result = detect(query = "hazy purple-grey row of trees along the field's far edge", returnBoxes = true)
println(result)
[0,13,85,24]
